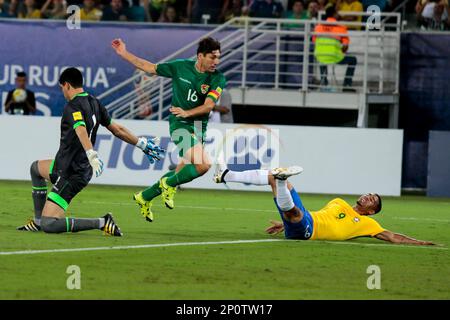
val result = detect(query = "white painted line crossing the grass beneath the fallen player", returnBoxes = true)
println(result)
[0,239,442,256]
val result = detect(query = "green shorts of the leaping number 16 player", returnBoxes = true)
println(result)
[169,120,208,157]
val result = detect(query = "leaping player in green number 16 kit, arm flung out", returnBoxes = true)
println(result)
[112,38,226,222]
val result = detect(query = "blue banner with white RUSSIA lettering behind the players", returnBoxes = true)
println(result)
[0,19,229,116]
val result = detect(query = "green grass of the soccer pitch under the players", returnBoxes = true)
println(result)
[0,181,450,300]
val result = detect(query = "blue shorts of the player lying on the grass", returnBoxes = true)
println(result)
[273,188,313,240]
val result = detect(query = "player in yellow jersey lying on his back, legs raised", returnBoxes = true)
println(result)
[214,166,433,245]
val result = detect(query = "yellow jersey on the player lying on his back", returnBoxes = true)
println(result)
[310,198,385,240]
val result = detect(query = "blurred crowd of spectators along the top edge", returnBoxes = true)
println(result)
[0,0,410,23]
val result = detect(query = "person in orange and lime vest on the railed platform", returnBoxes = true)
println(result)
[312,6,357,92]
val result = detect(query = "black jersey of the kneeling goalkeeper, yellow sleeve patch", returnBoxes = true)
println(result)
[51,92,111,179]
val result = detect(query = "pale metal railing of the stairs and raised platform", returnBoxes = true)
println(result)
[99,13,401,120]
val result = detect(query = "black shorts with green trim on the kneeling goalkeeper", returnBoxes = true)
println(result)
[47,172,90,211]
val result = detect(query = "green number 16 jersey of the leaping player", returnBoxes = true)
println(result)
[156,59,226,125]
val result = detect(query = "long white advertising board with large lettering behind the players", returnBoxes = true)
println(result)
[0,116,403,195]
